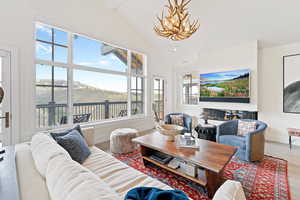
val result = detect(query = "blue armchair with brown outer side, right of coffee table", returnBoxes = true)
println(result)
[216,119,267,162]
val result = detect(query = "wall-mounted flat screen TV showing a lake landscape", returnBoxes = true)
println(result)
[200,69,250,103]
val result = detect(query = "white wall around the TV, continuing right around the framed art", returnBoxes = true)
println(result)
[173,42,300,145]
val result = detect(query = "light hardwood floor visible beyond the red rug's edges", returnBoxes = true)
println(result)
[96,135,300,200]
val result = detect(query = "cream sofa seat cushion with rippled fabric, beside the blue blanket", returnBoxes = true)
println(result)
[83,147,172,199]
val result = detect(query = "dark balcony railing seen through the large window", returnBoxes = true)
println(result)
[36,101,144,128]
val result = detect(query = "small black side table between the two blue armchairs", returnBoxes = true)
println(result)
[195,124,217,142]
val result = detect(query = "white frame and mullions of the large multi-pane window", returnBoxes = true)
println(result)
[34,22,148,131]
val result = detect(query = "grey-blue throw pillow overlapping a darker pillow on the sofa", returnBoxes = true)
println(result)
[55,130,91,164]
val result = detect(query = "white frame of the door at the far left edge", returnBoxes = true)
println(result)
[0,44,21,145]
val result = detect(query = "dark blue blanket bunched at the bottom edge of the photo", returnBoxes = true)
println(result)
[125,187,189,200]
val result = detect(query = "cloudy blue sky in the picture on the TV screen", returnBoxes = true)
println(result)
[200,69,250,81]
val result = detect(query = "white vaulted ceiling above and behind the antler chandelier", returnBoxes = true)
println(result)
[107,0,300,64]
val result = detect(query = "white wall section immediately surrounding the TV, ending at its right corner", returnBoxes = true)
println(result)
[173,41,258,116]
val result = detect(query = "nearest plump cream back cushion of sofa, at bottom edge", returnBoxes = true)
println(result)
[46,156,120,200]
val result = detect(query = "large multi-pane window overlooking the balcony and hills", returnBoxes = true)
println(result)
[36,23,146,129]
